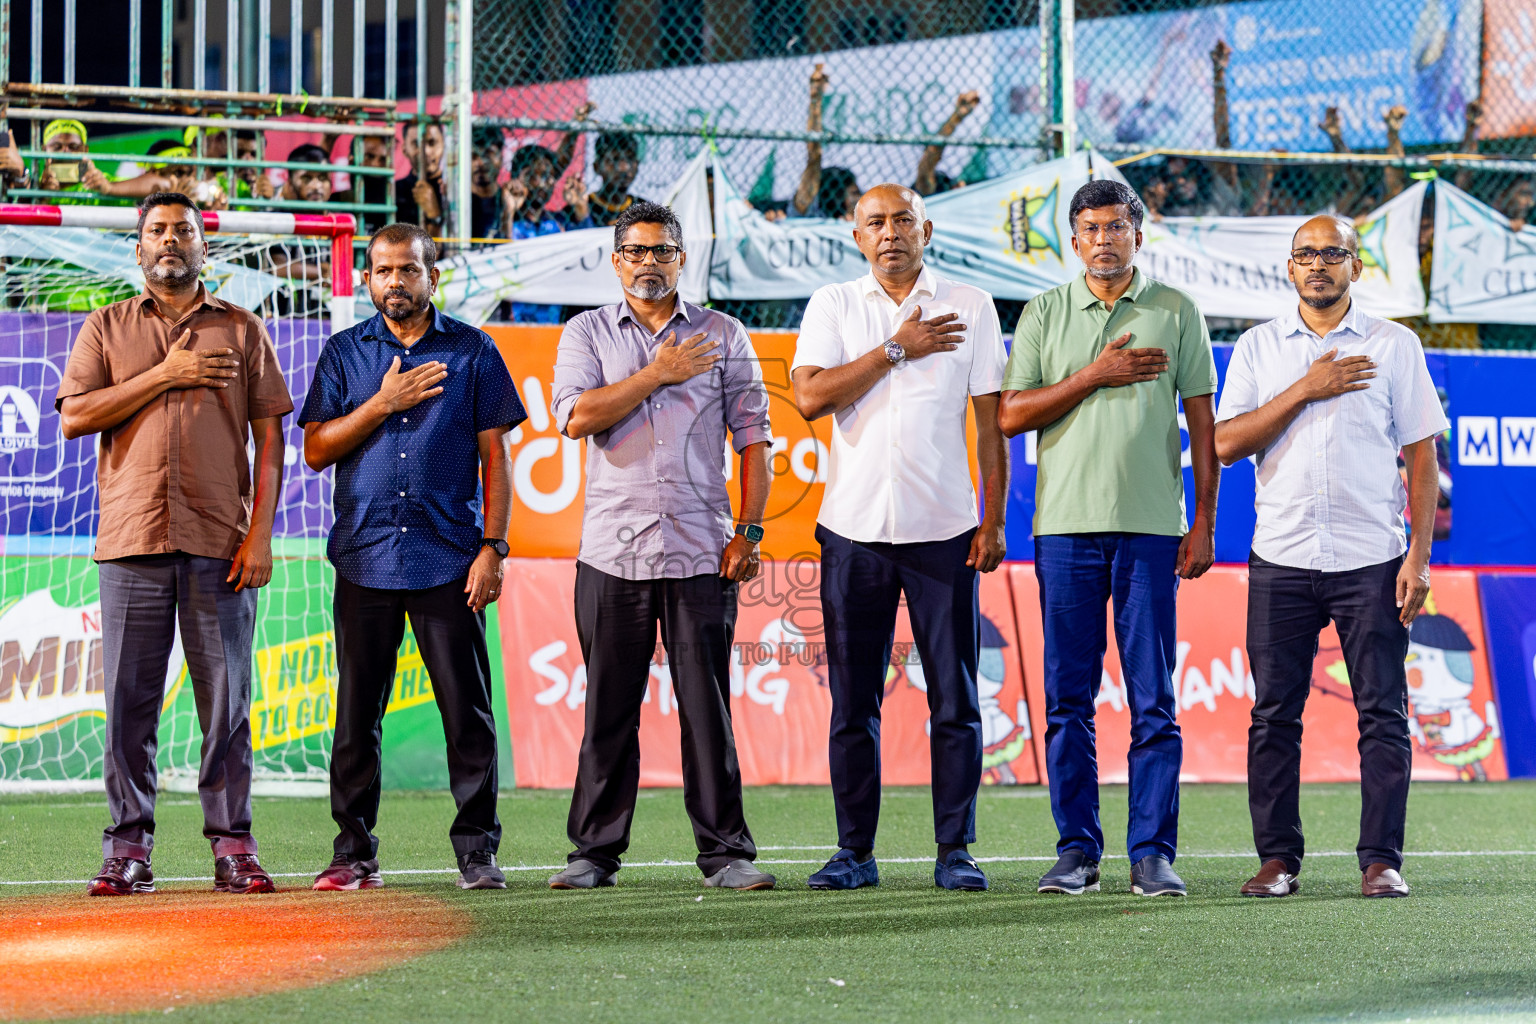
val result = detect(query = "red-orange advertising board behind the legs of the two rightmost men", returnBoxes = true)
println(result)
[1009,563,1508,783]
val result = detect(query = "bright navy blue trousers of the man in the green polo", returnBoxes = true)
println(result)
[1035,533,1184,863]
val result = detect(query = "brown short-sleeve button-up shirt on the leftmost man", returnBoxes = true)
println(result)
[54,287,293,562]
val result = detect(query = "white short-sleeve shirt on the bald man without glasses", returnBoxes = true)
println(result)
[794,267,1008,543]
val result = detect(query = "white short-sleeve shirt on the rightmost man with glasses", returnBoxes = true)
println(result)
[1217,306,1450,573]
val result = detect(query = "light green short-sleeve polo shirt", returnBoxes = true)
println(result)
[1003,269,1217,536]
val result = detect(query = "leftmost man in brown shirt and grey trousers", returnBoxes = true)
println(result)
[55,192,293,895]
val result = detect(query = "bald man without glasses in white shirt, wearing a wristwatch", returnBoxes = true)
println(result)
[793,184,1008,889]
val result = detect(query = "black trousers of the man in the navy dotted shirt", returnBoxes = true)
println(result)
[330,574,501,858]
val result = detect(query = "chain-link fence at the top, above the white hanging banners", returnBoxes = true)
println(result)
[473,0,1536,345]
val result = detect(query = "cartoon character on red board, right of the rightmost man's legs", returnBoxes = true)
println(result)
[1407,613,1499,781]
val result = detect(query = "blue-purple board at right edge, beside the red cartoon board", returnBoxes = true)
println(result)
[1478,573,1536,778]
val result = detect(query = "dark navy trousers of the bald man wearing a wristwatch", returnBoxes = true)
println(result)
[816,527,982,849]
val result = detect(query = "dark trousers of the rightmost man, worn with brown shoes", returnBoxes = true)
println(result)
[1247,554,1413,874]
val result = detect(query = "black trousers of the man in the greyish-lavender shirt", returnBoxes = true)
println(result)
[567,562,757,875]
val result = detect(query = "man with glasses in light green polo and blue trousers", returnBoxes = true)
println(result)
[998,181,1218,895]
